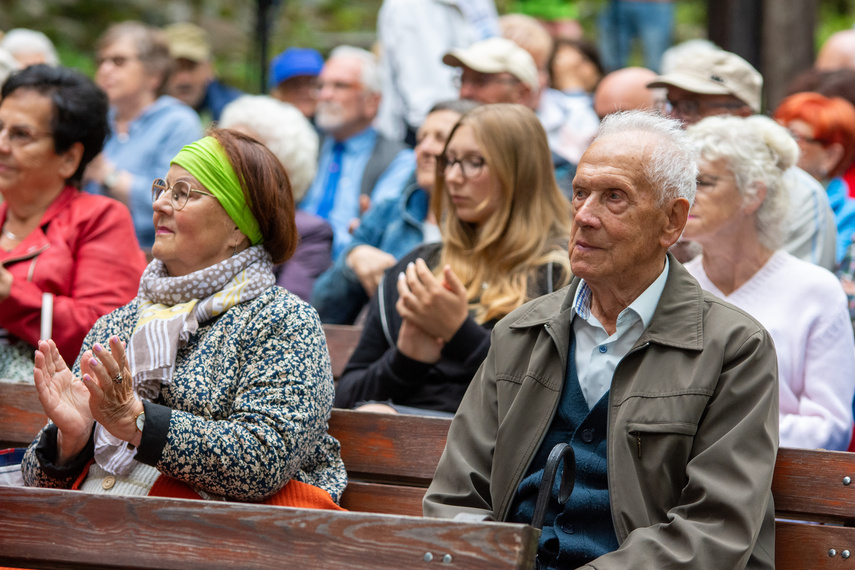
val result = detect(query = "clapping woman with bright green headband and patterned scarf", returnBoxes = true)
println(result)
[17,129,346,509]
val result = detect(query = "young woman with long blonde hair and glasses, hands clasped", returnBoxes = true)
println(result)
[336,104,570,414]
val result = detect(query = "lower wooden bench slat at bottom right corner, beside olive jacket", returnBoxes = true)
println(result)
[775,521,855,570]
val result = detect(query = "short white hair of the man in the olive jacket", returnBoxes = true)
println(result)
[594,111,698,206]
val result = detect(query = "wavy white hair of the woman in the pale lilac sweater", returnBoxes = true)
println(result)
[687,115,799,250]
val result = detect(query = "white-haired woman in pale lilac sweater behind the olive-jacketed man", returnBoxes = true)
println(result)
[684,116,855,450]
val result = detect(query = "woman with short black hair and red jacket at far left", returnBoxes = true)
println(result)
[0,65,145,380]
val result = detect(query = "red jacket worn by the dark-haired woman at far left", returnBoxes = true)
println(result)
[0,186,146,366]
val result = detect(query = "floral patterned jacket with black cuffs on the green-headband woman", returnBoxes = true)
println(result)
[22,286,347,502]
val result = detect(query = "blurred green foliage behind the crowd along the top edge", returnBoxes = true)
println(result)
[0,0,855,92]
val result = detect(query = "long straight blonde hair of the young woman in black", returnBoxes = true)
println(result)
[431,104,570,323]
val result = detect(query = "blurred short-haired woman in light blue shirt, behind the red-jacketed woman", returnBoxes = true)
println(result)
[85,21,202,250]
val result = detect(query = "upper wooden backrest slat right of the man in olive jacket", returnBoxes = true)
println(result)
[772,448,855,524]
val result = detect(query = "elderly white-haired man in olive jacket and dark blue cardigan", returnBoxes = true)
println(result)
[424,111,778,570]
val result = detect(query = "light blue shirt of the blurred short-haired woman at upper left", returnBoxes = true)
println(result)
[84,95,202,248]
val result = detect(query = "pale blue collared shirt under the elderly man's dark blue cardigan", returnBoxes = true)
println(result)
[570,257,669,409]
